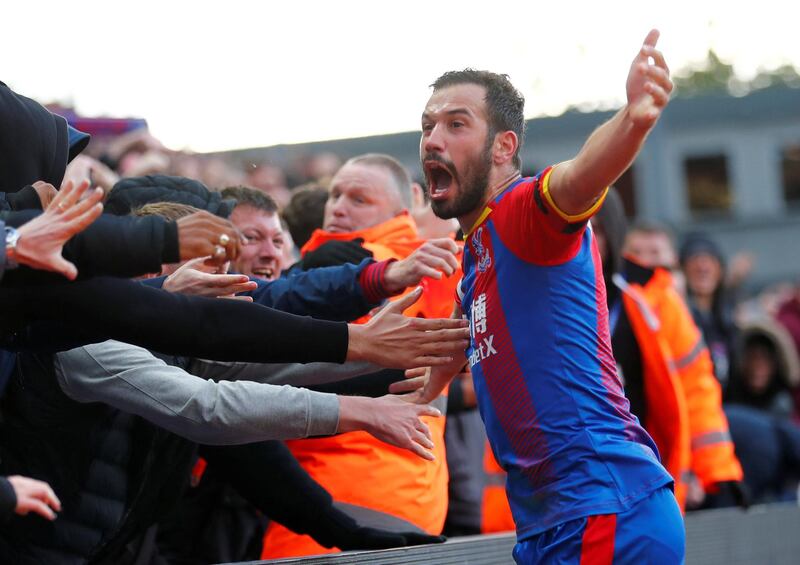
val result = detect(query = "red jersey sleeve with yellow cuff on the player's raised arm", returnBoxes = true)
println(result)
[492,167,608,265]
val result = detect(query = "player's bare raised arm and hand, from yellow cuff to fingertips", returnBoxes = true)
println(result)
[549,29,673,215]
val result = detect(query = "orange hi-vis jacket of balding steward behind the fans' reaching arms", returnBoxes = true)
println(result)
[262,213,461,559]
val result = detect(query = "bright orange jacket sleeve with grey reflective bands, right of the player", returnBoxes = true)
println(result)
[643,269,744,492]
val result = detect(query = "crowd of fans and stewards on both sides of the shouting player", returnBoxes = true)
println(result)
[0,76,800,563]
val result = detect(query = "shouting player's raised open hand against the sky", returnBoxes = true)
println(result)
[626,29,673,129]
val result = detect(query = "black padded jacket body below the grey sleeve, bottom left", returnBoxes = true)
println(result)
[0,354,196,565]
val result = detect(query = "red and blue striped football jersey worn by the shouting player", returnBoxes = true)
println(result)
[458,169,672,540]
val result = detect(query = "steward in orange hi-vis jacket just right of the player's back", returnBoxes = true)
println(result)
[594,191,743,504]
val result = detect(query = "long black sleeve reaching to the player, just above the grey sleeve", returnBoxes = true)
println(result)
[0,277,348,363]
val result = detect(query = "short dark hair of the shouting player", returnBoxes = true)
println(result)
[431,69,525,169]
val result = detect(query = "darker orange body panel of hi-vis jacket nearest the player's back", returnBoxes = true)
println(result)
[614,275,691,510]
